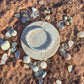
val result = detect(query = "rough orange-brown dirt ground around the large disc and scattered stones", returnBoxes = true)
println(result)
[0,0,84,84]
